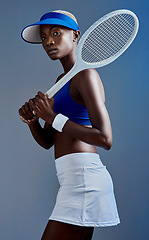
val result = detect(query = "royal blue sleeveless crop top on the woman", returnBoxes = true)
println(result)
[54,81,91,125]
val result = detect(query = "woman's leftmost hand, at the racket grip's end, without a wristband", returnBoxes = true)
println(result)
[19,102,38,125]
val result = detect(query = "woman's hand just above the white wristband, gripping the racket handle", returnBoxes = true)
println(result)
[29,92,57,124]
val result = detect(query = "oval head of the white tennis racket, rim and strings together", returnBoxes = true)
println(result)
[77,9,139,68]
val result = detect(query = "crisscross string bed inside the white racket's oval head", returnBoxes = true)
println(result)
[82,14,135,63]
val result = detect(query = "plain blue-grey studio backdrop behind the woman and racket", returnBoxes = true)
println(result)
[0,0,149,240]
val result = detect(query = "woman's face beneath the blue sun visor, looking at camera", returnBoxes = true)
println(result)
[40,25,76,60]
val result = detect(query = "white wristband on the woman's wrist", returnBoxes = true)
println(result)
[52,113,69,132]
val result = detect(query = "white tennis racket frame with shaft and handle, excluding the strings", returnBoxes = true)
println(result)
[46,9,139,98]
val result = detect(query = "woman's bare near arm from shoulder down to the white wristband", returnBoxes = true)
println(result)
[63,69,112,150]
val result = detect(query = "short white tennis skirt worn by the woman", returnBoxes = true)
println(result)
[49,153,120,227]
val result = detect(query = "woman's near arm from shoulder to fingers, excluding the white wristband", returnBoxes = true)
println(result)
[32,69,112,150]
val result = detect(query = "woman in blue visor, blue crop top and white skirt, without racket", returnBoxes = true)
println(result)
[19,10,119,240]
